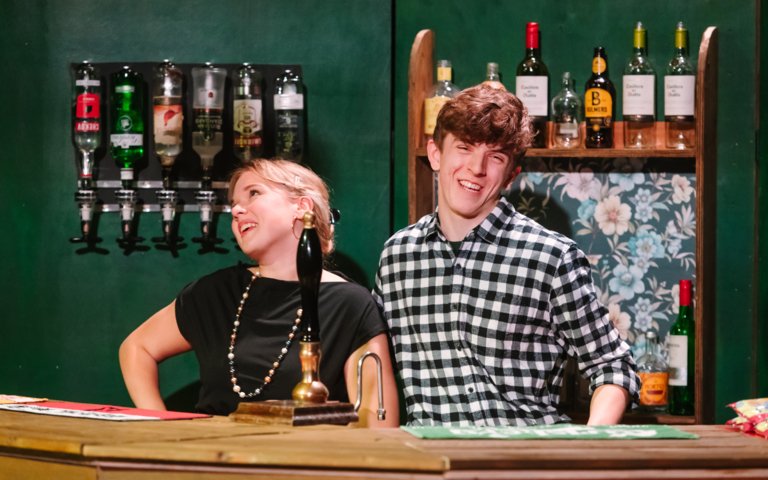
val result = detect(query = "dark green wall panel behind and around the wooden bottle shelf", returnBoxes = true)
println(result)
[393,0,768,421]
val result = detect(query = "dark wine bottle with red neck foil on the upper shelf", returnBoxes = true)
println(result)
[515,22,549,148]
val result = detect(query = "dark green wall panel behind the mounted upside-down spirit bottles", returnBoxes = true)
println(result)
[0,0,392,404]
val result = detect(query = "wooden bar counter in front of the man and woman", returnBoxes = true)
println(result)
[0,411,768,480]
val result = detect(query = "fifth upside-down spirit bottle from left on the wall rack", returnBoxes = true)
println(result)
[232,63,263,161]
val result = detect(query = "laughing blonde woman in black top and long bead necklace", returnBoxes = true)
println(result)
[120,160,399,427]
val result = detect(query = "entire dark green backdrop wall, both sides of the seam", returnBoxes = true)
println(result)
[0,0,768,420]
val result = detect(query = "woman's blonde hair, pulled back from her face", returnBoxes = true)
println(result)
[228,158,334,255]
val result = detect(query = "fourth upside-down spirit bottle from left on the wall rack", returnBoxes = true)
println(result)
[192,63,227,185]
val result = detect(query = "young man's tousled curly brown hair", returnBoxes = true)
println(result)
[433,84,533,164]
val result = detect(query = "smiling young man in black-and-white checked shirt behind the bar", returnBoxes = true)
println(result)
[374,86,639,425]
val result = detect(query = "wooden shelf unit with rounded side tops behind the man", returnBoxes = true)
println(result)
[408,27,718,423]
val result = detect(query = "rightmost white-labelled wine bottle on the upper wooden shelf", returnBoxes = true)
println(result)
[664,22,696,148]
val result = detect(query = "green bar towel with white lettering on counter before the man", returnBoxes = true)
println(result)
[400,424,699,440]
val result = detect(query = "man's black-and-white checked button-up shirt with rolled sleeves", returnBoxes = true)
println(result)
[374,198,639,425]
